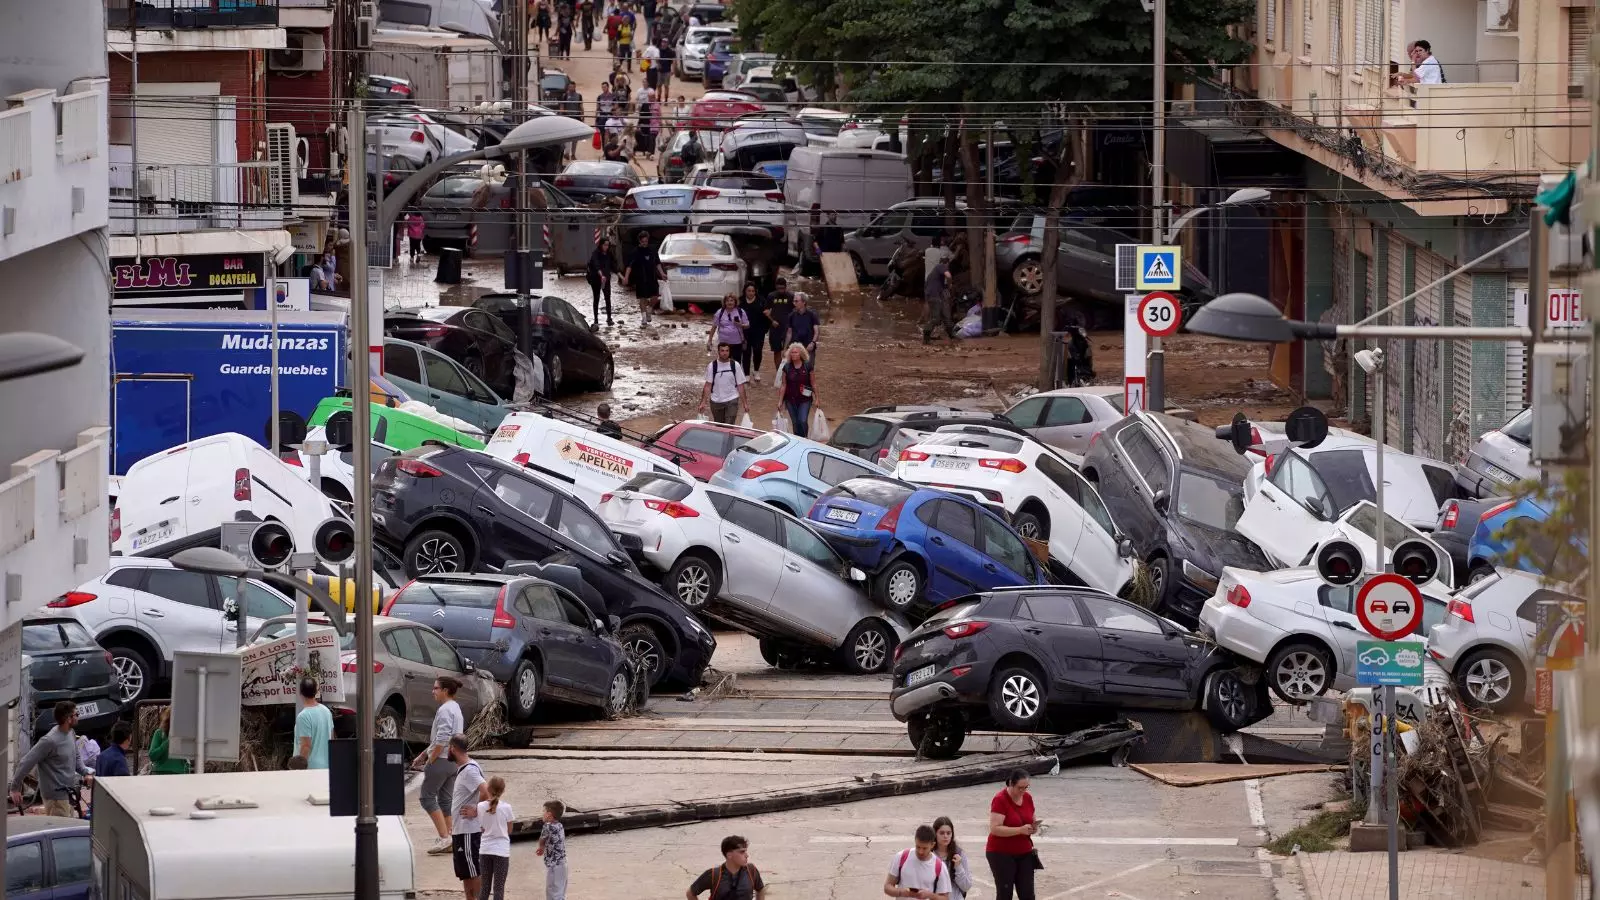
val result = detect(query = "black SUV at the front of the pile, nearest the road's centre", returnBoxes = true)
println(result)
[890,586,1272,757]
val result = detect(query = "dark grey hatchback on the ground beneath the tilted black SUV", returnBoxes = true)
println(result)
[384,575,632,722]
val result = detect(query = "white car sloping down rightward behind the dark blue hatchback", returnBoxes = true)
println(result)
[894,424,1133,594]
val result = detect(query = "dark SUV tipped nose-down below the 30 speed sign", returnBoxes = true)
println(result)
[1082,412,1274,625]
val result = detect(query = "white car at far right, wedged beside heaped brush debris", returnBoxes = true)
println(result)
[1427,567,1548,713]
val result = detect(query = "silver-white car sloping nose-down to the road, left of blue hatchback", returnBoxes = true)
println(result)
[600,474,910,674]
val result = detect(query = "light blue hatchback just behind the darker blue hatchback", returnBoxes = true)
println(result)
[710,431,883,516]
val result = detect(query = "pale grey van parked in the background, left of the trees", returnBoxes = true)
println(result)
[784,147,912,256]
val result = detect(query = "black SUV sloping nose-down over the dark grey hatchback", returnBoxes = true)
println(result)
[373,445,717,685]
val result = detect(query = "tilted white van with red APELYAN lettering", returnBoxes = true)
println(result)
[483,413,694,509]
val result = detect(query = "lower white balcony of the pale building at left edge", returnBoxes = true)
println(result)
[0,428,110,628]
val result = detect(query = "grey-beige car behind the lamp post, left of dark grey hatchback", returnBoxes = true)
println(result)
[251,615,506,743]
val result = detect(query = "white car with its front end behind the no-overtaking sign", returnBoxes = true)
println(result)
[1200,565,1450,703]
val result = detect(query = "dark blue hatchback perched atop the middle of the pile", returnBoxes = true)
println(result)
[810,474,1050,620]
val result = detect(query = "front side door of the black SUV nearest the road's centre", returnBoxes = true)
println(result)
[1078,594,1192,708]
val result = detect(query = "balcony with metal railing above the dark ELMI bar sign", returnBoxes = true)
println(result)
[110,144,283,234]
